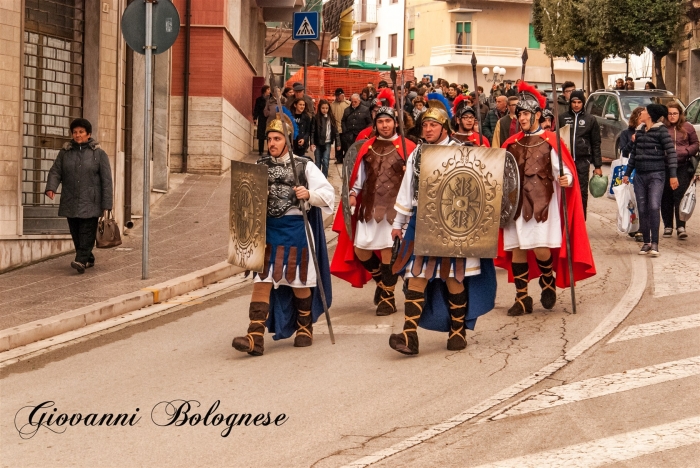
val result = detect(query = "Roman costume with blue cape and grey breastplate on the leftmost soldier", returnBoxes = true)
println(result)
[232,109,335,356]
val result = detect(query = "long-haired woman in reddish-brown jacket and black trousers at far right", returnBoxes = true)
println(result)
[661,103,700,240]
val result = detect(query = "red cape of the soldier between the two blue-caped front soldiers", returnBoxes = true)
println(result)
[331,137,416,288]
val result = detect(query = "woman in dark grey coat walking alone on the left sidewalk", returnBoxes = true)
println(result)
[44,119,112,274]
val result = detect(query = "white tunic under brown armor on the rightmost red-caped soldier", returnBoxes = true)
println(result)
[503,132,574,250]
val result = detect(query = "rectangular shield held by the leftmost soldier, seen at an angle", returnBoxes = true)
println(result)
[228,161,267,273]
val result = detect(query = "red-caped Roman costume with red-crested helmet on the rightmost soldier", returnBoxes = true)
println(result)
[496,82,595,316]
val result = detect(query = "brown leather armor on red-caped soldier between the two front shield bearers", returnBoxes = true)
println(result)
[357,139,406,224]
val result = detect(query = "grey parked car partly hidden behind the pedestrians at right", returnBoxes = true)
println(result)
[586,89,685,159]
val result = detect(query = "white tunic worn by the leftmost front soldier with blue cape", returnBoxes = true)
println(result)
[253,154,335,289]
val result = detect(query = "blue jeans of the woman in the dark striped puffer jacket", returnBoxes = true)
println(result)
[634,171,666,244]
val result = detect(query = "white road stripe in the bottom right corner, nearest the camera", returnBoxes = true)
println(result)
[470,417,700,468]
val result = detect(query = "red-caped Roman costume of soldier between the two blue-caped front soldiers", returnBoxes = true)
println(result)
[331,101,415,315]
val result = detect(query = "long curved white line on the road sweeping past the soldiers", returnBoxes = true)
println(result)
[343,220,647,468]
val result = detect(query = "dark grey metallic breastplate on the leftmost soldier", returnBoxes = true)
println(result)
[258,156,309,218]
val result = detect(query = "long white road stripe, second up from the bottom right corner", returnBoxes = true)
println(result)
[479,356,700,423]
